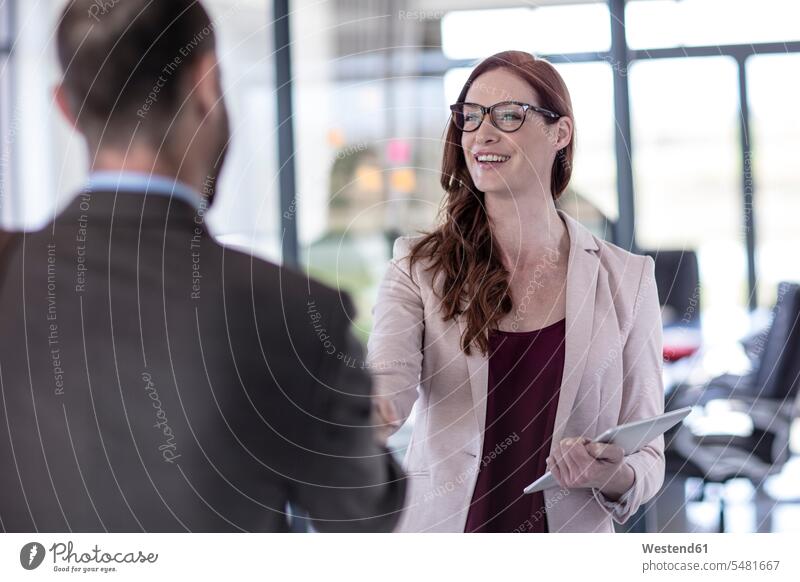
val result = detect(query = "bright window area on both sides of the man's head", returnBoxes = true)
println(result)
[0,0,280,258]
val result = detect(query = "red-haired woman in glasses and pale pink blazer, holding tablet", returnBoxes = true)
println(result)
[368,51,664,532]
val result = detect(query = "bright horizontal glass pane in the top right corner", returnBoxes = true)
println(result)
[625,0,800,49]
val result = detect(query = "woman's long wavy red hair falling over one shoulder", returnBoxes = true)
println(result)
[409,51,575,354]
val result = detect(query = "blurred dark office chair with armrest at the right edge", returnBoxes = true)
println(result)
[665,283,800,531]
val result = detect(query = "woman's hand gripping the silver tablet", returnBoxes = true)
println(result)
[547,437,634,500]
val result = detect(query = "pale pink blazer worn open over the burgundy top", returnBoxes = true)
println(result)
[367,211,664,532]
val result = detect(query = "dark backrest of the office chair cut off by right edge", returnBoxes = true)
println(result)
[754,282,800,400]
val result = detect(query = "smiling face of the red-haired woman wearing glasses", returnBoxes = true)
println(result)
[461,68,570,193]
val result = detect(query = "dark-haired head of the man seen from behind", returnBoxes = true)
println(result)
[56,0,229,196]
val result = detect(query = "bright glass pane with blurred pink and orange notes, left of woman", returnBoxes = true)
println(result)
[293,4,449,340]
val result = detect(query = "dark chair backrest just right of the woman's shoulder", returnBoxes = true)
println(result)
[645,250,700,325]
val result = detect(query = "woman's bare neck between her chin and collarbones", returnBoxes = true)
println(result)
[485,191,569,268]
